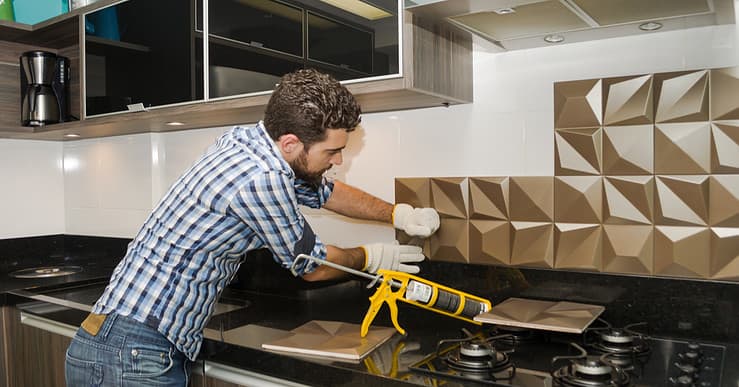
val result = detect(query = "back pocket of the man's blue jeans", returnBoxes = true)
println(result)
[121,343,174,378]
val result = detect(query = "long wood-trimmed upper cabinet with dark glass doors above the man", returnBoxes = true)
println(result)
[0,0,472,141]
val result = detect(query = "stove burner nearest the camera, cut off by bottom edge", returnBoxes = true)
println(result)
[551,343,631,387]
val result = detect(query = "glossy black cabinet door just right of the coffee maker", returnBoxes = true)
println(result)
[85,0,203,116]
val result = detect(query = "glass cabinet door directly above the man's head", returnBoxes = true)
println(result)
[205,0,400,98]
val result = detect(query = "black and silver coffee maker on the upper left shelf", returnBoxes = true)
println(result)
[20,51,70,126]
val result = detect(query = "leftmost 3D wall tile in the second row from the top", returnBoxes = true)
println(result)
[554,128,602,176]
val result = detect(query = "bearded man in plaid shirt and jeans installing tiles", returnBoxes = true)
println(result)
[66,70,439,387]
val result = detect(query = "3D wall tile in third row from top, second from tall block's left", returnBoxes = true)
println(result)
[603,176,654,225]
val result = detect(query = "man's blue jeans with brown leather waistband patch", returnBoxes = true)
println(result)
[65,313,192,387]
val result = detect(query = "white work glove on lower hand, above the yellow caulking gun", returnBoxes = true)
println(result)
[362,241,425,274]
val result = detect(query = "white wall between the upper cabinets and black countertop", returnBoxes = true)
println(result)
[0,21,739,246]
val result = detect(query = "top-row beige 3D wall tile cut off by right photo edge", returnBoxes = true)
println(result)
[710,67,739,120]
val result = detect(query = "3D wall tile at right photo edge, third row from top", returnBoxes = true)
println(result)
[708,175,739,227]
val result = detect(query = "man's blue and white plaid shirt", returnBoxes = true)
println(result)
[93,122,333,360]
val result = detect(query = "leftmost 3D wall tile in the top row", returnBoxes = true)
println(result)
[554,79,602,128]
